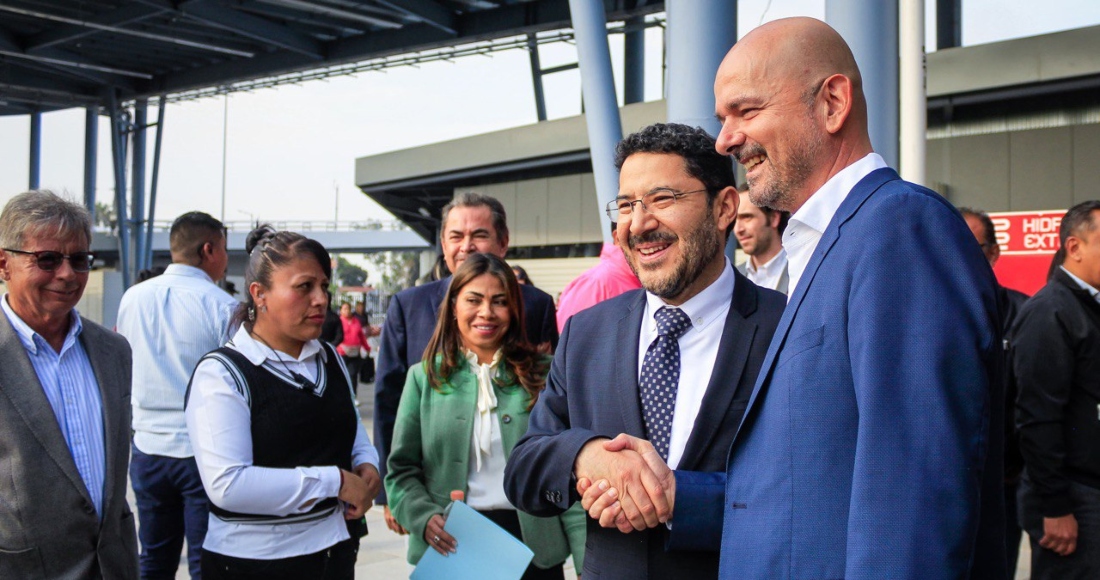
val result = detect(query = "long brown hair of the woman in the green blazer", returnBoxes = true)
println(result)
[424,254,549,411]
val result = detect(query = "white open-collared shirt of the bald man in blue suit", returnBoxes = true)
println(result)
[783,153,887,300]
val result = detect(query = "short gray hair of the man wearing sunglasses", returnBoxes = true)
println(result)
[0,189,91,250]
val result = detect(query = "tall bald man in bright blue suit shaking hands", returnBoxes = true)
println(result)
[583,18,1005,580]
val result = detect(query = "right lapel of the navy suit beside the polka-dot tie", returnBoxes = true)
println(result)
[680,272,757,469]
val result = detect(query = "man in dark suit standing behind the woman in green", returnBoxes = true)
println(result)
[374,193,558,534]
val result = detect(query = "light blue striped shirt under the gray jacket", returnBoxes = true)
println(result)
[0,294,107,517]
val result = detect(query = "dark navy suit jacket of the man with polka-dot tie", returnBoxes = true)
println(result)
[504,272,785,580]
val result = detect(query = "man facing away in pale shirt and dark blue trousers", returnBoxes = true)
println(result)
[117,211,238,580]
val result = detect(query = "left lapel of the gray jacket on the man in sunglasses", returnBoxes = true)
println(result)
[0,310,91,504]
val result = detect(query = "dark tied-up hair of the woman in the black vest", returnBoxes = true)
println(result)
[231,223,332,331]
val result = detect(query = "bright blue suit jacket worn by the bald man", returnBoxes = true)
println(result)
[673,168,1005,580]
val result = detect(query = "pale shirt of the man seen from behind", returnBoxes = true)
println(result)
[117,264,238,458]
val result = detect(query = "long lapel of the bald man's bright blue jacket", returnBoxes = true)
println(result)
[734,168,900,441]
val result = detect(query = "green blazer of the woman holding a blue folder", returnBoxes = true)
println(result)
[385,356,585,570]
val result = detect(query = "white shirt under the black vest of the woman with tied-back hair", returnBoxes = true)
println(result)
[186,327,378,560]
